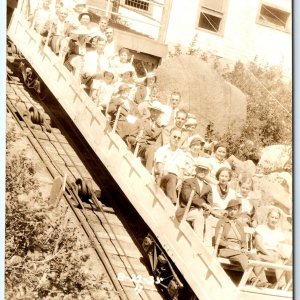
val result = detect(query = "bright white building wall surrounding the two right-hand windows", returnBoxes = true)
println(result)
[166,0,292,76]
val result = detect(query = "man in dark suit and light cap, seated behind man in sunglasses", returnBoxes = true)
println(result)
[128,101,162,173]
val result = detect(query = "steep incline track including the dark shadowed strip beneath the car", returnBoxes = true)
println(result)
[7,80,163,300]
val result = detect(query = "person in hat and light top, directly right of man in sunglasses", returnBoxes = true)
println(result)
[183,136,208,178]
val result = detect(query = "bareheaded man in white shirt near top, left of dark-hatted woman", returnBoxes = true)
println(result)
[50,7,72,58]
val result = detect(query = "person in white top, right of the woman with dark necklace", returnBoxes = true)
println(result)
[236,176,257,227]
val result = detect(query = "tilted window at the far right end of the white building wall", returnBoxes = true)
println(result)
[257,4,291,31]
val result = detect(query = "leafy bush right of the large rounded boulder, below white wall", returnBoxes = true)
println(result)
[221,62,292,159]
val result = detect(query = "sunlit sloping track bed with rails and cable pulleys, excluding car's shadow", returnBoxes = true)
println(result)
[7,75,163,299]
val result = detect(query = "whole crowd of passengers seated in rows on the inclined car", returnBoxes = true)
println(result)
[30,0,287,288]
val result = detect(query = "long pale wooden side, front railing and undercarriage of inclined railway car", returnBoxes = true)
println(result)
[7,1,293,300]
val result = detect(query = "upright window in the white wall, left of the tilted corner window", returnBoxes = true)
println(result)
[198,0,225,34]
